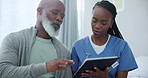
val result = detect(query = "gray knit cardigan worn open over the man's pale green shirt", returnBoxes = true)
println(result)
[0,27,72,78]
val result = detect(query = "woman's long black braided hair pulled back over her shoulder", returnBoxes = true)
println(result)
[93,0,123,39]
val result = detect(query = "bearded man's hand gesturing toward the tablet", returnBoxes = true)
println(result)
[46,59,74,72]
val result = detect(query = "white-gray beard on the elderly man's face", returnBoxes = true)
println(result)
[42,17,59,37]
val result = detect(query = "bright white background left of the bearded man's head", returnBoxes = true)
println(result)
[0,0,40,44]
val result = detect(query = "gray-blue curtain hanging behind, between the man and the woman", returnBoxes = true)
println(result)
[58,0,78,49]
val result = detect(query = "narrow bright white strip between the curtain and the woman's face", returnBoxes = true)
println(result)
[80,0,98,38]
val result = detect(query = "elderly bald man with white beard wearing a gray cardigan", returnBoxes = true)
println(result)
[0,0,74,78]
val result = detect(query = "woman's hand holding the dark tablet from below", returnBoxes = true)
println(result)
[81,67,108,78]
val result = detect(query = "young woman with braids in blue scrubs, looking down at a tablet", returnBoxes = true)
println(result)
[71,1,138,78]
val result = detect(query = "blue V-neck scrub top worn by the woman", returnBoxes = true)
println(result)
[71,36,138,78]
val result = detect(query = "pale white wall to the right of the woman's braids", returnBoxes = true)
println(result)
[117,0,148,56]
